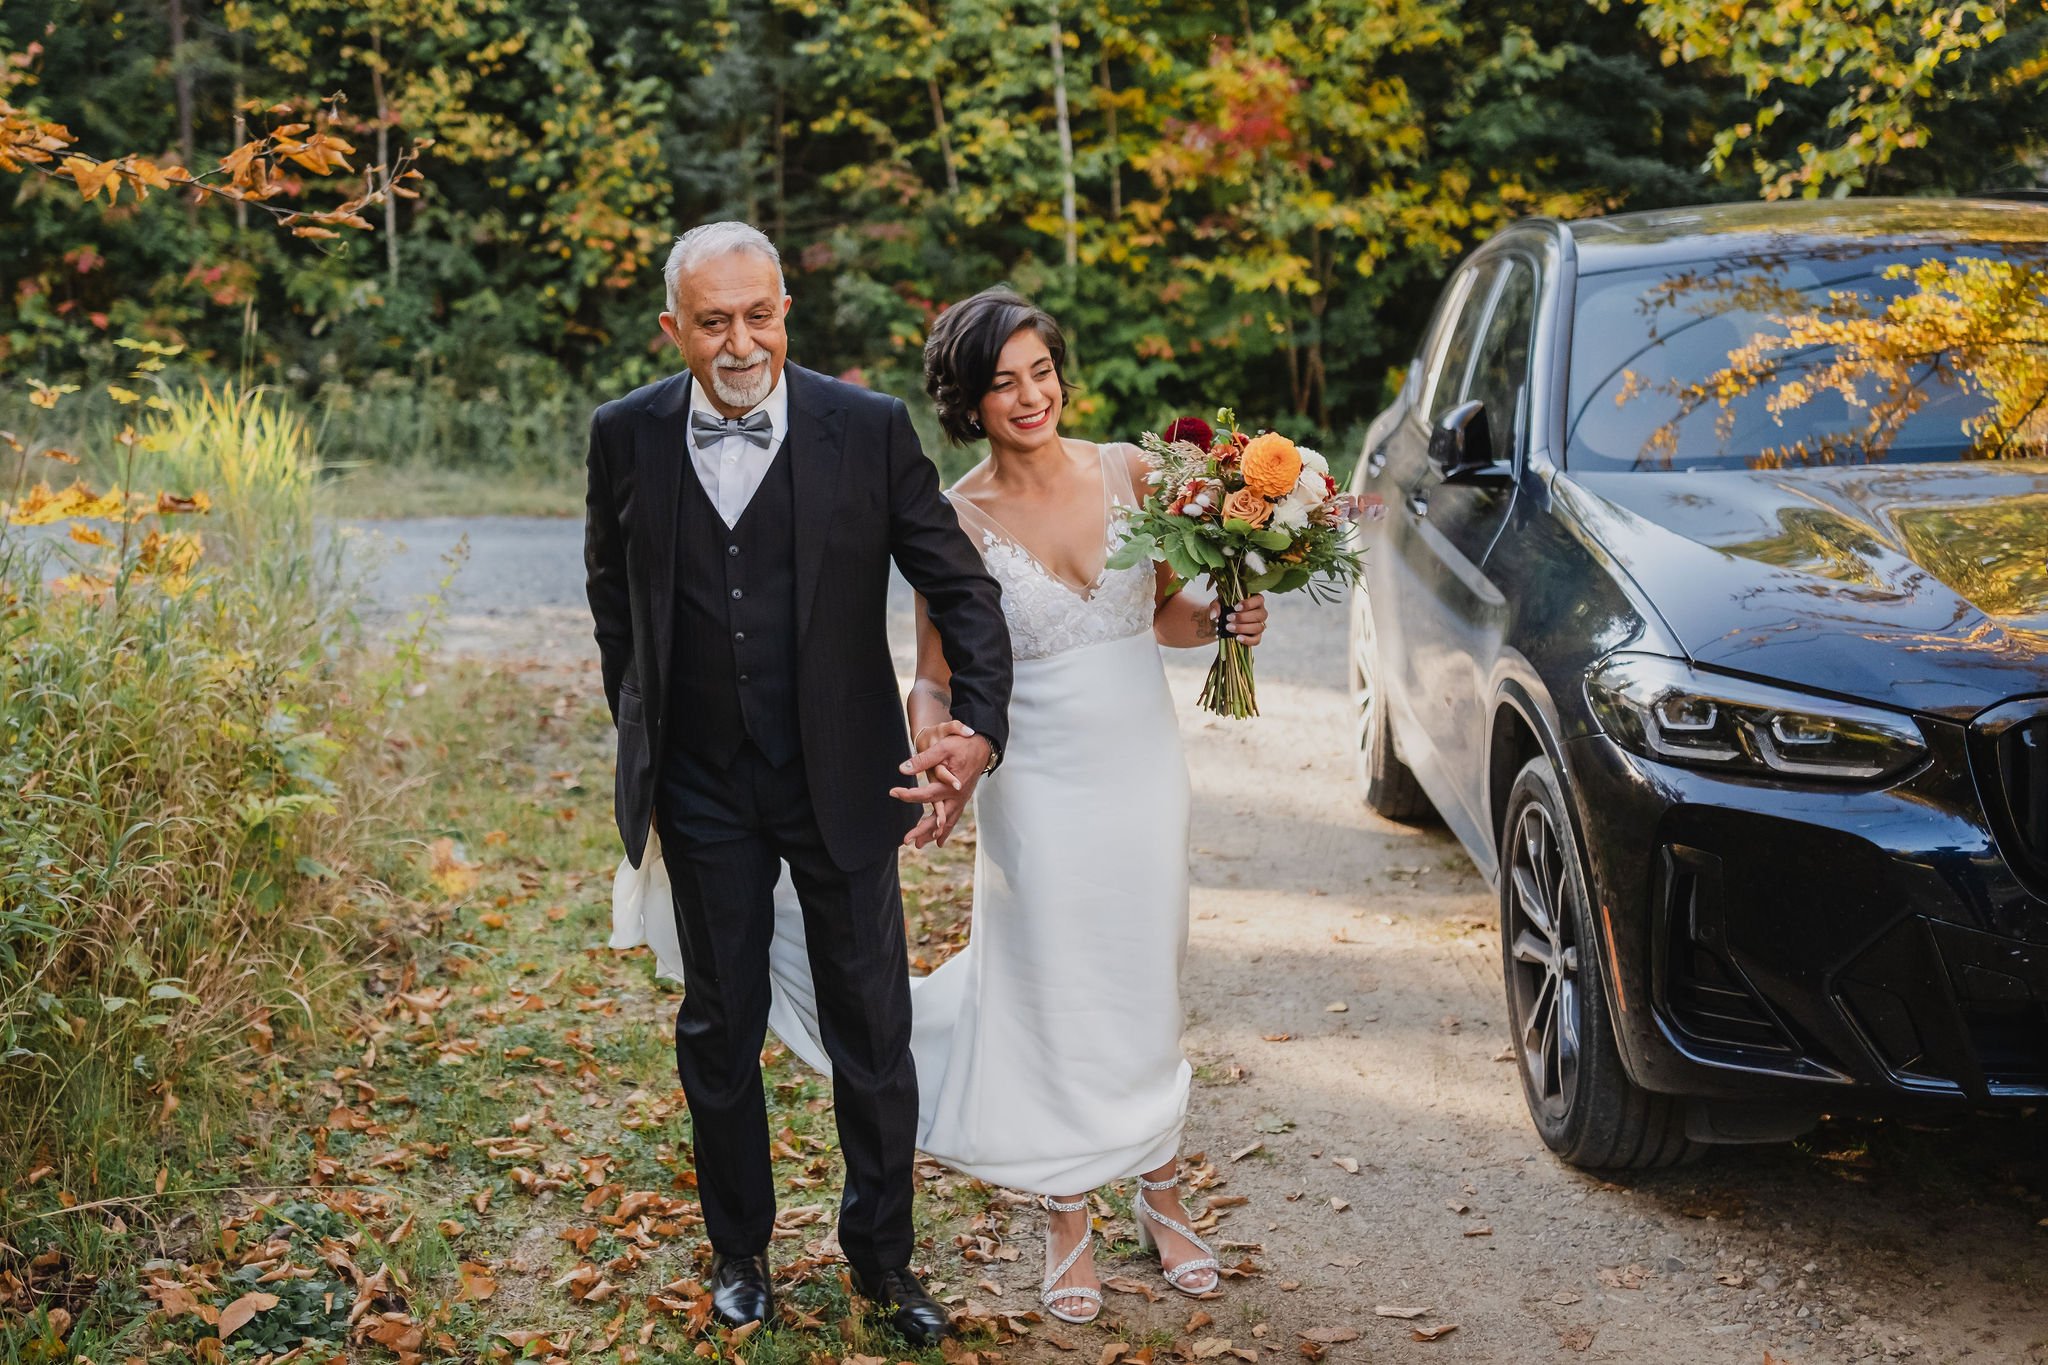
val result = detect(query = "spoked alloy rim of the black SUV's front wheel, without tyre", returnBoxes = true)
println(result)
[1507,802,1579,1121]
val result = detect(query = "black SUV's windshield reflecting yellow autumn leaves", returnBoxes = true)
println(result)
[1565,241,2048,471]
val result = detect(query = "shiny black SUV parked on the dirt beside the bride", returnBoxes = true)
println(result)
[1350,201,2048,1166]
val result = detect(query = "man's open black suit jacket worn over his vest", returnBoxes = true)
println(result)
[584,364,1010,870]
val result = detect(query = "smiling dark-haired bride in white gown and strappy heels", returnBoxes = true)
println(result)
[612,289,1266,1322]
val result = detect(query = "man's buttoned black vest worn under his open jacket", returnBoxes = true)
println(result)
[668,440,801,767]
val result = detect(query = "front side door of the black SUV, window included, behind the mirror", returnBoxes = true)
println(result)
[1399,252,1540,845]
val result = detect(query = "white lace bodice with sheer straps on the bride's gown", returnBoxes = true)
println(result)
[948,446,1155,659]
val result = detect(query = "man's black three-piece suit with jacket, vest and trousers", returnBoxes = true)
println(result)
[584,366,1010,1271]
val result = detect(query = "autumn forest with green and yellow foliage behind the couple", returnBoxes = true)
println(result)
[0,0,2048,510]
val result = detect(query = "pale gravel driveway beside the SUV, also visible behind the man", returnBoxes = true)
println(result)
[356,520,2048,1365]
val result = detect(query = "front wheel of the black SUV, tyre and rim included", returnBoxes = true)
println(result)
[1501,755,1702,1171]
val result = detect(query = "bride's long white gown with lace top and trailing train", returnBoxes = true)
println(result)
[612,446,1190,1195]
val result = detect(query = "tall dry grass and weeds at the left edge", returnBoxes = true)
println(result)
[0,387,411,1197]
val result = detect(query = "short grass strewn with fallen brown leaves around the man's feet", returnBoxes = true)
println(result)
[0,658,1034,1365]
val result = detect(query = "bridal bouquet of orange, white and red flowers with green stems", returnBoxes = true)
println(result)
[1110,407,1360,718]
